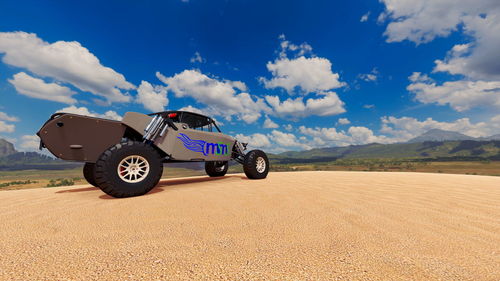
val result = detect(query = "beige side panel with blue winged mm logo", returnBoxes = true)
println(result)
[155,123,235,161]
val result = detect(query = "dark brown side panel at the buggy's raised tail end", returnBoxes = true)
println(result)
[37,113,125,162]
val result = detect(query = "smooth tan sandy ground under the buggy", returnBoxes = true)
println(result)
[0,172,500,280]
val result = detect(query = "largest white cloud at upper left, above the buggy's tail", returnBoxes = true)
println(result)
[0,32,135,103]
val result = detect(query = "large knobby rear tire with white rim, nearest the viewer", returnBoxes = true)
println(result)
[95,140,163,198]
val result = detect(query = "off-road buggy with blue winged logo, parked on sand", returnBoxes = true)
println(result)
[37,111,269,197]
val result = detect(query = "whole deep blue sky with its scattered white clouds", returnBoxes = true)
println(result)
[0,0,500,152]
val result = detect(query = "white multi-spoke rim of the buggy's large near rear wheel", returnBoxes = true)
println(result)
[117,155,149,183]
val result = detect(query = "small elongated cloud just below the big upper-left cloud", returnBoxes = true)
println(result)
[8,72,76,104]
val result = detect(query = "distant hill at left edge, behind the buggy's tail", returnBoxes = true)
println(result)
[0,139,81,171]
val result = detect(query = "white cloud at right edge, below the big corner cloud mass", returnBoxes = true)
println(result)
[407,72,500,111]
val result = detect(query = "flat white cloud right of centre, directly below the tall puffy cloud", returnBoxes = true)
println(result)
[265,92,345,119]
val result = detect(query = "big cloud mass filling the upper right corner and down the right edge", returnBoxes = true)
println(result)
[383,0,500,111]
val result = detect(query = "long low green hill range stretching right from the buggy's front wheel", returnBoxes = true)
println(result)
[270,140,500,164]
